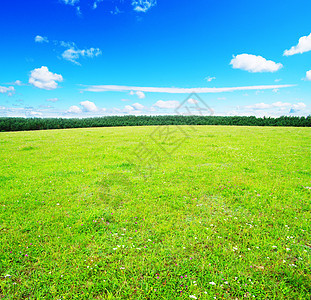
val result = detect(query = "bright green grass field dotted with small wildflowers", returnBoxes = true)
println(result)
[0,126,311,299]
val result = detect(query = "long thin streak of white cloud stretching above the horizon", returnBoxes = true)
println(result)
[83,84,295,94]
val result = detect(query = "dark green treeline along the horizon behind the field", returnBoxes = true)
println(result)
[0,115,311,131]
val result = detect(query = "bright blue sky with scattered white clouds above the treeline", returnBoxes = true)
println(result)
[0,0,311,118]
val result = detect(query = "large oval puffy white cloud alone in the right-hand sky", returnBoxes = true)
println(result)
[230,53,283,73]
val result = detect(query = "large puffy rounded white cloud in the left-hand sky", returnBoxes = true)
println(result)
[29,66,63,90]
